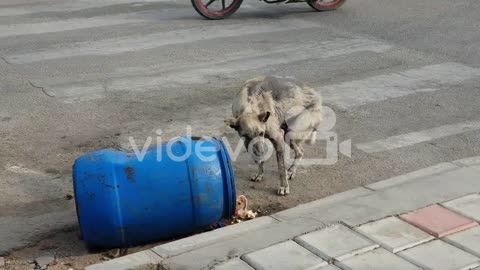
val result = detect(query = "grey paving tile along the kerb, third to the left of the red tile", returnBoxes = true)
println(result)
[243,240,328,270]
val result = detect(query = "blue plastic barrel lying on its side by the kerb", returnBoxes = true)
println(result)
[73,137,236,248]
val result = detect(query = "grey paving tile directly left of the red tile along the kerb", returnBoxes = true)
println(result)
[355,217,433,253]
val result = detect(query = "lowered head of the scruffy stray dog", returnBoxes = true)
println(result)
[225,112,270,162]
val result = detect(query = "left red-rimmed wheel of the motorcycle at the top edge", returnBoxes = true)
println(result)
[191,0,243,20]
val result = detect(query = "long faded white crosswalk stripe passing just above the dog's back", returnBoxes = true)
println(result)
[40,35,391,99]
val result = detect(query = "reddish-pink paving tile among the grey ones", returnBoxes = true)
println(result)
[400,204,478,237]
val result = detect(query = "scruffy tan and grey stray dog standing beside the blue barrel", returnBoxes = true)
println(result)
[225,76,323,196]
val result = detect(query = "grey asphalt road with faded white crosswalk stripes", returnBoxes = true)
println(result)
[0,0,480,255]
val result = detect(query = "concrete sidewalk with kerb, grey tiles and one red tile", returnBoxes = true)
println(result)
[86,157,480,270]
